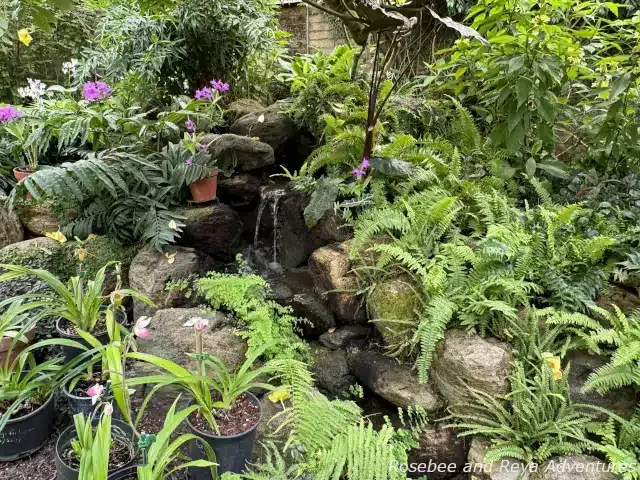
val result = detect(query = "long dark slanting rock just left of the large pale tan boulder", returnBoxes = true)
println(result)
[348,351,442,413]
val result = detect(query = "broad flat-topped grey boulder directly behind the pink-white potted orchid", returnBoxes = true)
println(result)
[136,308,247,373]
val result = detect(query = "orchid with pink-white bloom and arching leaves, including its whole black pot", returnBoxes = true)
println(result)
[127,326,276,480]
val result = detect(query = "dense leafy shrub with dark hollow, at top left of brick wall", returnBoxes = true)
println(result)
[79,0,278,95]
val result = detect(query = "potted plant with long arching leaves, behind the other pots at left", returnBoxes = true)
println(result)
[0,262,153,361]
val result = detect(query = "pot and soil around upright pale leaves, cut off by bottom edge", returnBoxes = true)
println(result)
[56,419,136,480]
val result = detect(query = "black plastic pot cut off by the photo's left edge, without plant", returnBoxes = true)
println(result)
[0,394,55,462]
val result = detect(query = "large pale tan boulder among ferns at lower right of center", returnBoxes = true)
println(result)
[431,329,513,405]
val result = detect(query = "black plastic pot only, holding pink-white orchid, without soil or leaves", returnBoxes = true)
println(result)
[187,392,262,480]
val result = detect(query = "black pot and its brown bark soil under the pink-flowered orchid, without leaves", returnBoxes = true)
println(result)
[187,392,262,480]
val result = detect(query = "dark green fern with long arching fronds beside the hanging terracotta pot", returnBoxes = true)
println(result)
[11,143,213,249]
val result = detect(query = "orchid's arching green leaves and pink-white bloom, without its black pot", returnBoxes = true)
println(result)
[126,317,276,433]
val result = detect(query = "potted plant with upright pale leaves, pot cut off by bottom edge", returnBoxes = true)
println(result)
[56,403,136,480]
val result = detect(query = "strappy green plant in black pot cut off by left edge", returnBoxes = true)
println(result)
[0,300,88,461]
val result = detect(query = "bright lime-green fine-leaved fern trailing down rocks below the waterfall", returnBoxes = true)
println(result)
[198,262,308,358]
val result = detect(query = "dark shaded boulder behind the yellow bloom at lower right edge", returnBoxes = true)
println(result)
[564,352,638,420]
